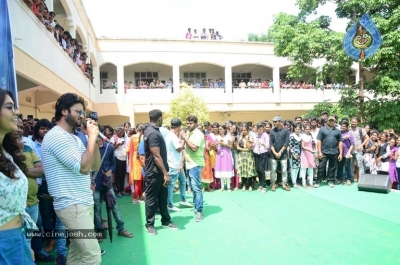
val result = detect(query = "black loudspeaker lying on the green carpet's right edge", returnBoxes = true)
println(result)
[358,174,392,193]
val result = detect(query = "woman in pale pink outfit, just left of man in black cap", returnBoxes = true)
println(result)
[300,125,316,188]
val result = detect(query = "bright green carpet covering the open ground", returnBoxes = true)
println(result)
[38,185,400,265]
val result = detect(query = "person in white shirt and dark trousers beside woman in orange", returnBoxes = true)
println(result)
[110,126,126,198]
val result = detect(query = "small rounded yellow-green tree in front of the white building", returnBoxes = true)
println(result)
[164,88,210,126]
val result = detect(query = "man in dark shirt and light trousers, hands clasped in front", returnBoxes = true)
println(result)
[269,116,290,191]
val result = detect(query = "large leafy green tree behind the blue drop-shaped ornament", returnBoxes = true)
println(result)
[268,0,400,129]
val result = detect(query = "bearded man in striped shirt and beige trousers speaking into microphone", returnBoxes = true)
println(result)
[42,93,101,265]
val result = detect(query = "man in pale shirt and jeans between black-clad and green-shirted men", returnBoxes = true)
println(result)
[160,118,193,212]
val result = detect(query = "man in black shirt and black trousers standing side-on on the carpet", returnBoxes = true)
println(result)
[144,109,178,236]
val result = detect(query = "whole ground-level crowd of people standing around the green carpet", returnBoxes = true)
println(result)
[0,87,400,265]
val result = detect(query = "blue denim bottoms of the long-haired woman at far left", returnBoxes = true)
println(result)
[0,227,35,265]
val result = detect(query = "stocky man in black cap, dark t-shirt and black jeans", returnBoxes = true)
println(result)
[314,116,343,188]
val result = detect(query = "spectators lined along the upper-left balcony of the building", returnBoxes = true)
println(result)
[24,0,93,80]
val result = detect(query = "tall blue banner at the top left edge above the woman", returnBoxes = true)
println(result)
[0,0,18,106]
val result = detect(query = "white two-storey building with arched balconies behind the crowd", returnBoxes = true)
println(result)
[9,0,366,126]
